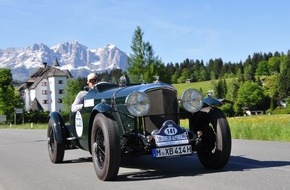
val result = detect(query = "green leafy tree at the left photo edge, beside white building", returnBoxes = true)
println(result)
[0,68,19,122]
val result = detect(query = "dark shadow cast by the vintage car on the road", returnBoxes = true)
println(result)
[116,154,290,181]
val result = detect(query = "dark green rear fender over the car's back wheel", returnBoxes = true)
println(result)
[48,111,65,143]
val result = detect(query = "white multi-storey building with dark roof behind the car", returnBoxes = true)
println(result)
[19,60,72,112]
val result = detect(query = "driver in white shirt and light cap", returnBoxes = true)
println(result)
[71,73,98,112]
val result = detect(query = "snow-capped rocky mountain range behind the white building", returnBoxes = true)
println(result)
[0,42,128,81]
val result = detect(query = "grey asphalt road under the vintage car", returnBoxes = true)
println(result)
[0,129,290,190]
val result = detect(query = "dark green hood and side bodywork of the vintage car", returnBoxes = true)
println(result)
[71,83,176,150]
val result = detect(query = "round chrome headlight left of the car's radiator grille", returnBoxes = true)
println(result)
[125,92,150,117]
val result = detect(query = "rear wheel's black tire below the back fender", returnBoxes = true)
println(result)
[47,119,65,164]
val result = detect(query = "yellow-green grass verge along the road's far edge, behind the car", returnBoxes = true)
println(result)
[0,114,290,142]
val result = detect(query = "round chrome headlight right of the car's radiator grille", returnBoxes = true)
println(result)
[181,89,203,113]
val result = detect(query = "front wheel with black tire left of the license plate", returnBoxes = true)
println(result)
[91,113,121,181]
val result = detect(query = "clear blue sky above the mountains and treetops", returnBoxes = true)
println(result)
[0,0,290,63]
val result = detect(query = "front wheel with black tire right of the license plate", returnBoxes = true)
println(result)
[196,107,232,169]
